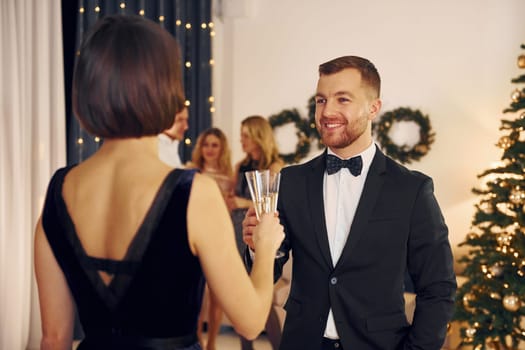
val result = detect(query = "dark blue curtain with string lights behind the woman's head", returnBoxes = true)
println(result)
[62,0,214,164]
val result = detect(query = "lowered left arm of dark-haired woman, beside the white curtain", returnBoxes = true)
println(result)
[35,219,74,350]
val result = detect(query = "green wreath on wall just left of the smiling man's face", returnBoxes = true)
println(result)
[268,108,310,164]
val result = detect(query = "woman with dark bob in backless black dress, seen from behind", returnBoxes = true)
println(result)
[35,16,284,350]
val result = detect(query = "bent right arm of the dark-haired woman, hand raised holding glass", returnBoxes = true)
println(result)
[188,174,284,339]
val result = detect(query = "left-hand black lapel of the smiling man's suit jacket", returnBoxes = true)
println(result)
[305,150,333,268]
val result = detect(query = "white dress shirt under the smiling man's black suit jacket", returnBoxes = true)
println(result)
[323,142,376,339]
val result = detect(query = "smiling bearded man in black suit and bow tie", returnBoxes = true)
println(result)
[243,56,456,350]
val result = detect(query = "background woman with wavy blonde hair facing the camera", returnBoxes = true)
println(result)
[187,128,233,350]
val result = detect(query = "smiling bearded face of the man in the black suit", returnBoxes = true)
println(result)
[315,68,381,150]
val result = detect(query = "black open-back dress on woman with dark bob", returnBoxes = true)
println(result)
[42,167,204,350]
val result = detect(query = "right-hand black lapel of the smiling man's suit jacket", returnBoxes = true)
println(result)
[334,149,385,268]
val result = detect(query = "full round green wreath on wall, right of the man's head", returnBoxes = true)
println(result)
[372,107,435,163]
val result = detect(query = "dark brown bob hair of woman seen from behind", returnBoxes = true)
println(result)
[72,15,184,138]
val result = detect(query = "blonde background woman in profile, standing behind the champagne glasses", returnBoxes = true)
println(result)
[232,115,284,350]
